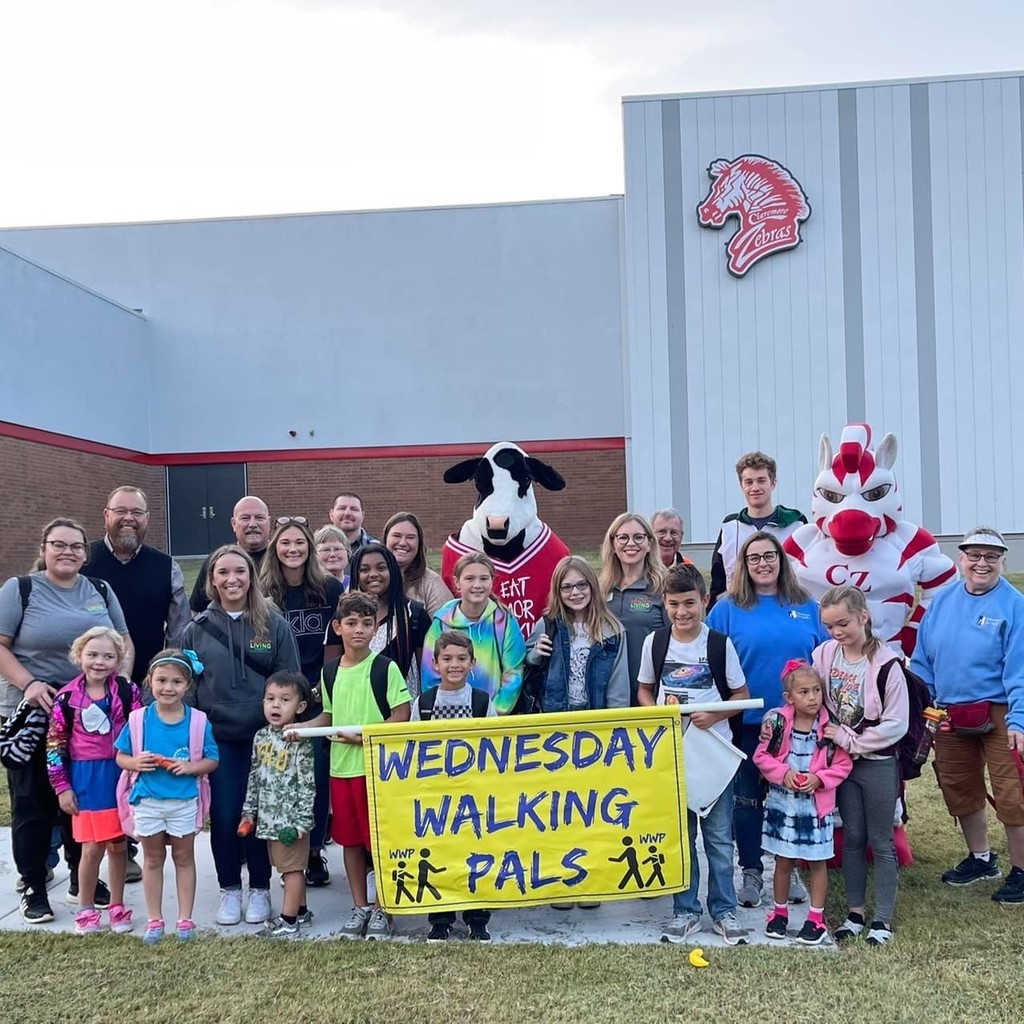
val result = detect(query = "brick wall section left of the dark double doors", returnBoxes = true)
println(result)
[0,437,167,582]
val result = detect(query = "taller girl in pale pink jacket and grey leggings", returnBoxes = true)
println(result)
[813,587,909,946]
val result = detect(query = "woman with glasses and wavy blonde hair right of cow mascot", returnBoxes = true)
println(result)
[600,512,669,707]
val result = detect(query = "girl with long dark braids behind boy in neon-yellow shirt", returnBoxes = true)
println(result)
[351,544,430,697]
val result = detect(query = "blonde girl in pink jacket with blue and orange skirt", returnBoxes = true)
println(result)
[46,626,141,935]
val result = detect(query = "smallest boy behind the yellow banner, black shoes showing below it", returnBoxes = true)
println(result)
[413,630,497,942]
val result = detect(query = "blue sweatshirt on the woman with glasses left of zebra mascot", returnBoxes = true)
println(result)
[708,595,828,726]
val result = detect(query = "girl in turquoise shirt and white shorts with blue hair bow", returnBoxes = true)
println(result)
[112,648,218,944]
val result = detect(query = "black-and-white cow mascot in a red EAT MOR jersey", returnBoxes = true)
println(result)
[441,441,569,637]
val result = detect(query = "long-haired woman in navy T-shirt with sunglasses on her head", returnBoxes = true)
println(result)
[259,515,345,887]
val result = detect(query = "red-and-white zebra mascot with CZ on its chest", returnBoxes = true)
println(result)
[782,423,956,866]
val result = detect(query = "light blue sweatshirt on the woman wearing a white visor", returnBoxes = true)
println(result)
[910,579,1024,732]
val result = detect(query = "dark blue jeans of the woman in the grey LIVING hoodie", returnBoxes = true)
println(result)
[210,739,270,889]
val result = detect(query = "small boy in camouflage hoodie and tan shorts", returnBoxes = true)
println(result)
[239,672,316,939]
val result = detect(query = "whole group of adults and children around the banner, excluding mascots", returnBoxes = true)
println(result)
[0,453,1024,945]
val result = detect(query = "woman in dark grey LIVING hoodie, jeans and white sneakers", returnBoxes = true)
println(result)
[181,544,299,925]
